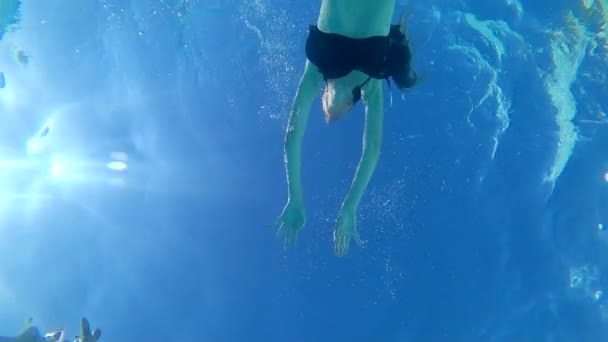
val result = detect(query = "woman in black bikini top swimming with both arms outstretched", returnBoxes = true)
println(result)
[277,0,417,256]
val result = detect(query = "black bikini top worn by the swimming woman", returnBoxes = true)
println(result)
[306,25,411,80]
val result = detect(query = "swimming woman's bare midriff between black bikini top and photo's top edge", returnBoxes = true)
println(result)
[317,0,396,38]
